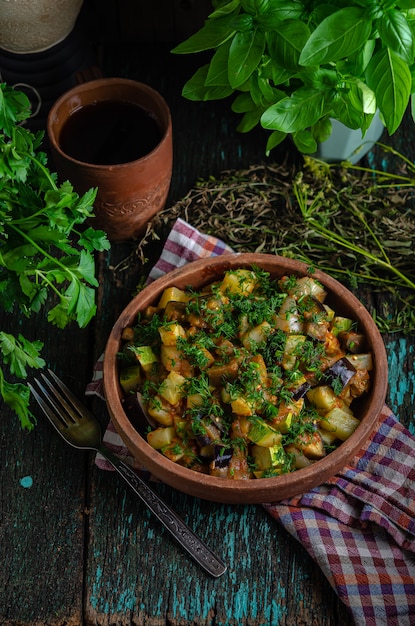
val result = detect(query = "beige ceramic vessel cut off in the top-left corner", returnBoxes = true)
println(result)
[0,0,83,54]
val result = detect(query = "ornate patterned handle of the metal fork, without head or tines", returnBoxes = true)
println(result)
[99,447,227,578]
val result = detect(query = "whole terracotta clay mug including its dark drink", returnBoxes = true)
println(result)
[47,73,173,242]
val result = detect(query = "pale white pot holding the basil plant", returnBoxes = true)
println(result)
[315,113,385,164]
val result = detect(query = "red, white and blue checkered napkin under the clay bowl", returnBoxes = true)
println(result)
[87,219,415,626]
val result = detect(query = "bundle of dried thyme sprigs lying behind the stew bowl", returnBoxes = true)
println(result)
[135,146,415,331]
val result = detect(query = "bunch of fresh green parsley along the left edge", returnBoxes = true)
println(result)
[0,83,110,430]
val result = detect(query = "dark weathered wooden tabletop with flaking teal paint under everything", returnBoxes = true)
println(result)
[0,41,415,626]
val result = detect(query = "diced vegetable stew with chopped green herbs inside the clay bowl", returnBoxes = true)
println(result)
[119,265,373,480]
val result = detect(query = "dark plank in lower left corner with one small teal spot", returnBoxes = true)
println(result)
[0,378,86,626]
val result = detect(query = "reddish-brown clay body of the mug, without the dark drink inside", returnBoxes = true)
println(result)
[47,78,173,242]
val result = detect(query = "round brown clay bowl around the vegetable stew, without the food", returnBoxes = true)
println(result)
[104,254,388,504]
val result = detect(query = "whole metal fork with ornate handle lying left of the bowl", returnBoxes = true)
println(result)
[29,370,227,578]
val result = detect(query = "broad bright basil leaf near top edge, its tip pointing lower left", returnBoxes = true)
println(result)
[299,7,372,66]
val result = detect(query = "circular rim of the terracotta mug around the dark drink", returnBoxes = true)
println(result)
[46,77,172,170]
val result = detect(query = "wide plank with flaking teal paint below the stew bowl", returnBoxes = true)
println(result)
[86,473,351,626]
